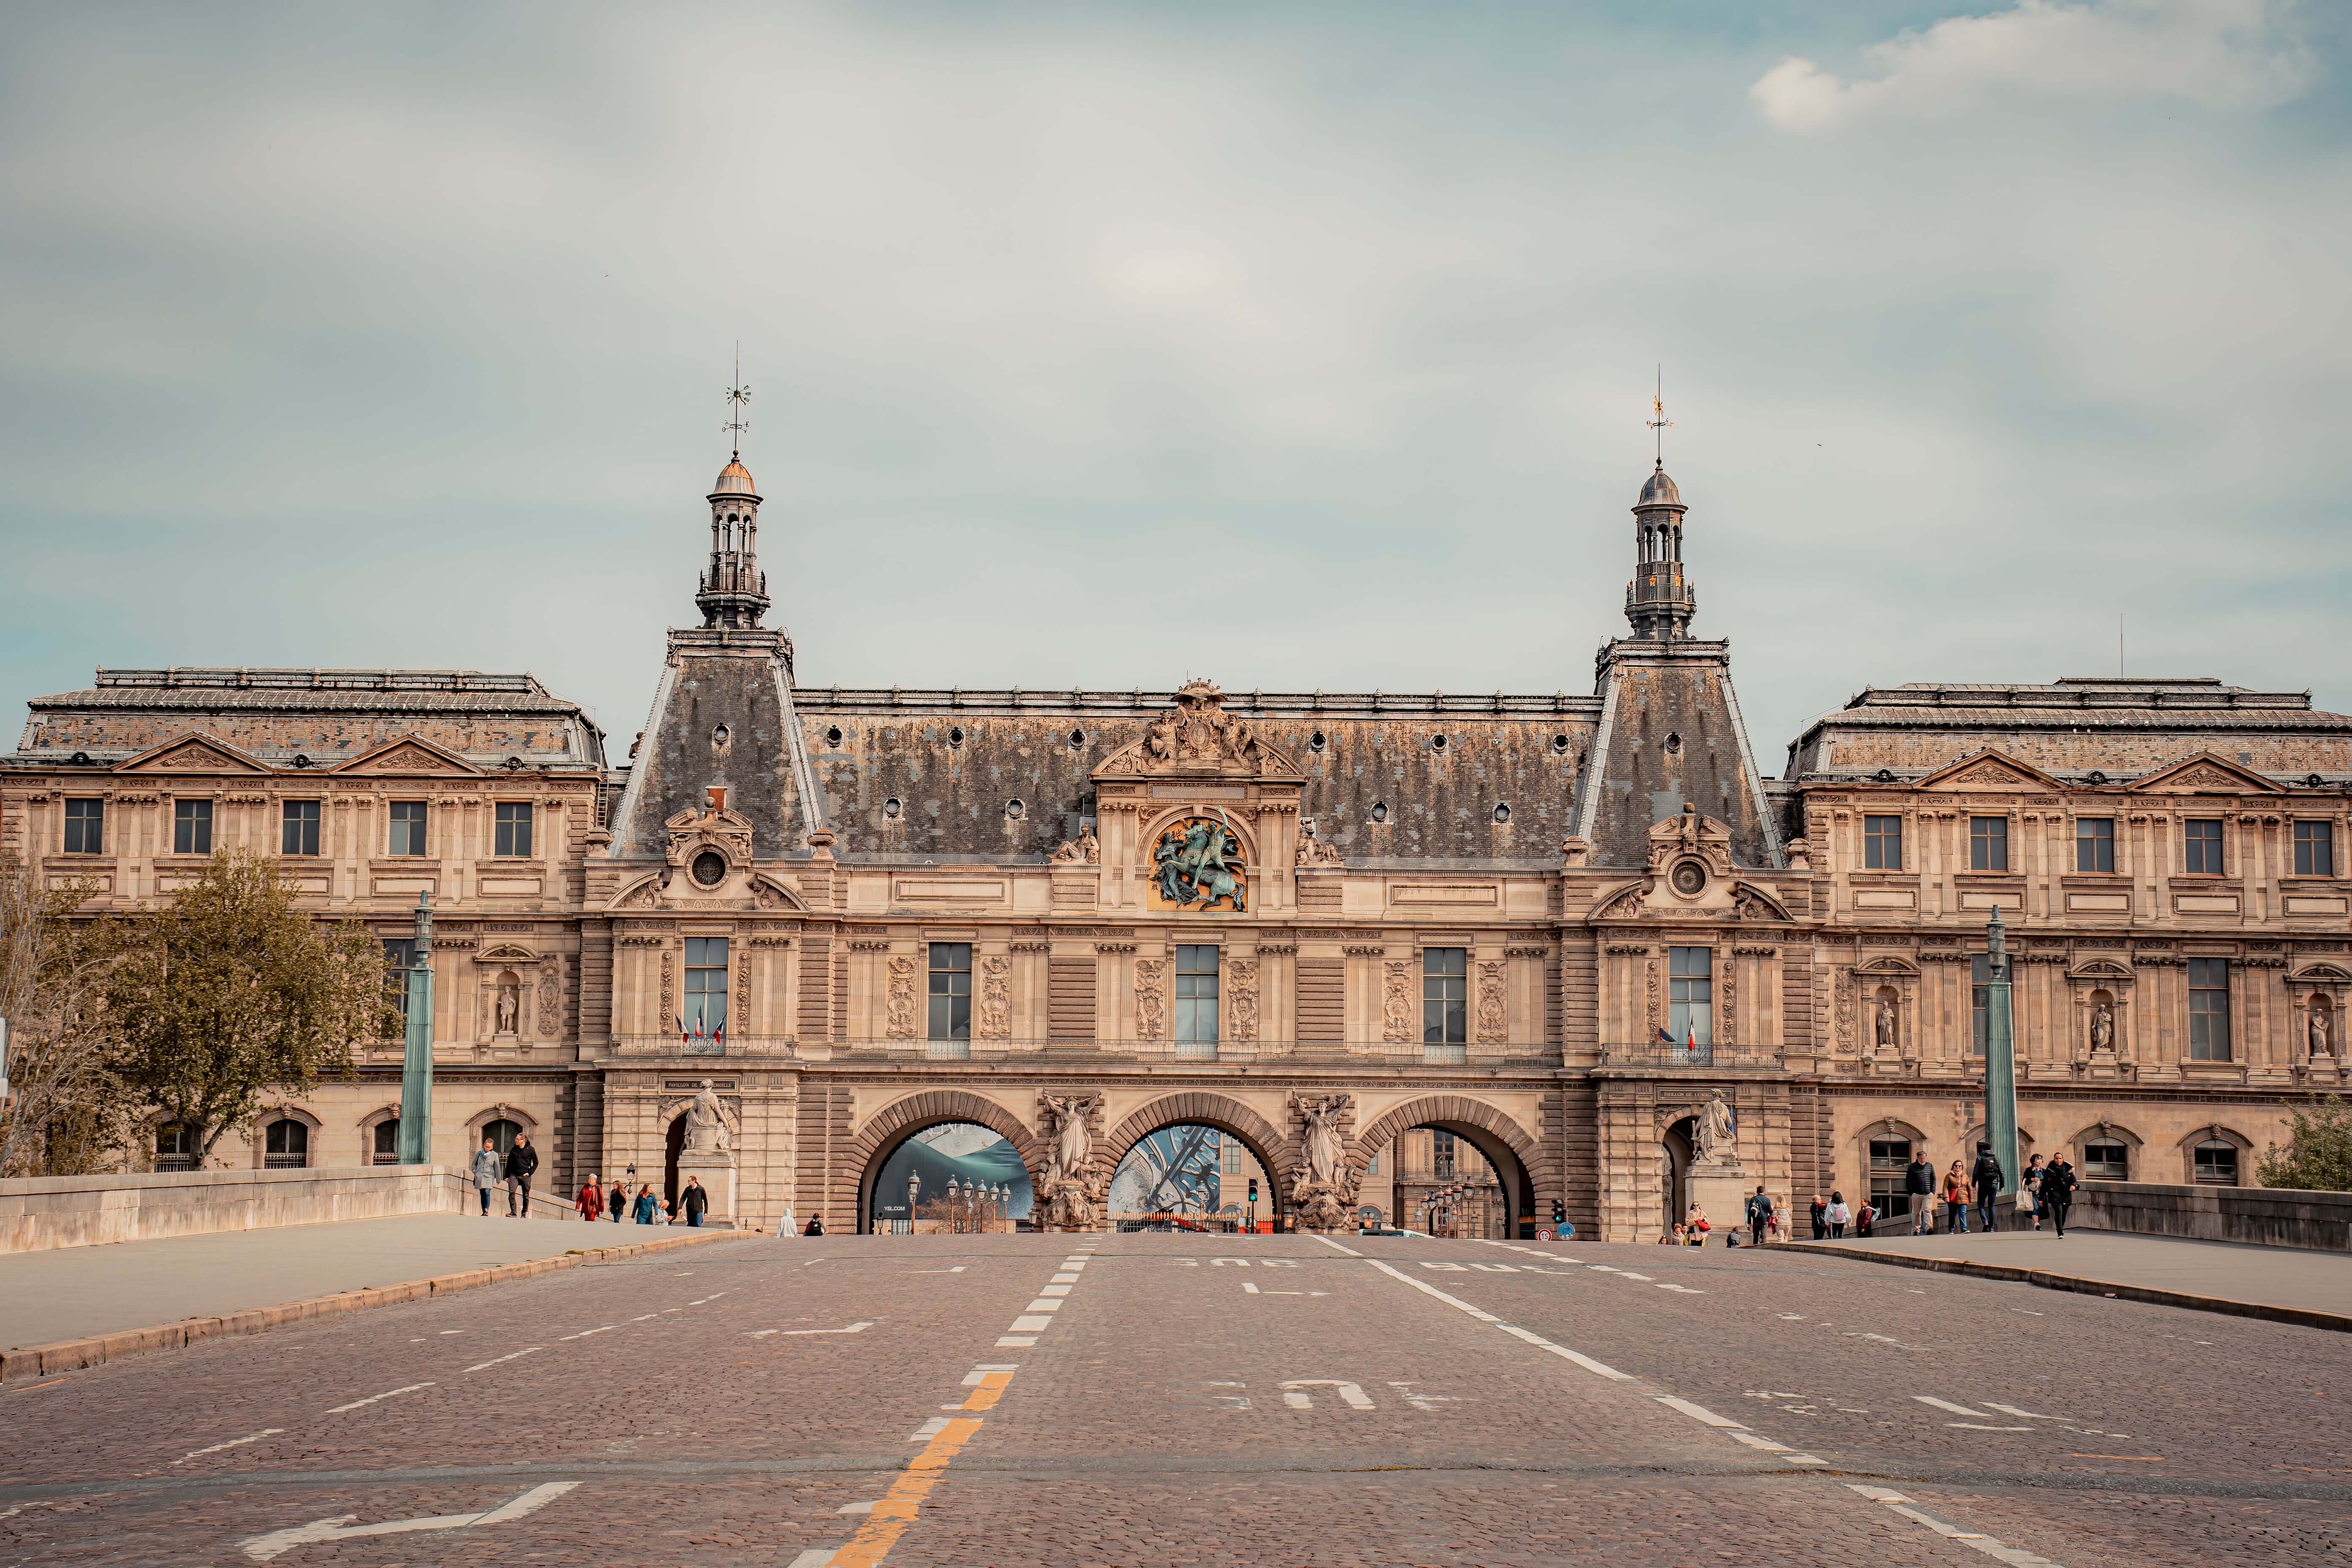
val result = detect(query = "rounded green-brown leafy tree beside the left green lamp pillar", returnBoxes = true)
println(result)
[106,851,400,1164]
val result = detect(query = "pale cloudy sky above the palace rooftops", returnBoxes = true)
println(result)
[0,0,2352,771]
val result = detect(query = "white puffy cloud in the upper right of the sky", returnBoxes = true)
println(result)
[1748,0,2314,132]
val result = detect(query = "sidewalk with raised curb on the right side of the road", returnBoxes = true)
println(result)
[1799,1230,2352,1314]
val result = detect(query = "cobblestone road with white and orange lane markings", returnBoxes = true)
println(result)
[0,1236,2352,1568]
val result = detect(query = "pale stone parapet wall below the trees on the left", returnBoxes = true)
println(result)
[0,1166,485,1253]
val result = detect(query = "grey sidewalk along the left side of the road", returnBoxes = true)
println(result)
[0,1213,738,1352]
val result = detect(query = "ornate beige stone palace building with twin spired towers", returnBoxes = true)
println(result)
[0,446,2352,1239]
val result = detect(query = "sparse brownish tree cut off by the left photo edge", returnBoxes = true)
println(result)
[0,860,132,1176]
